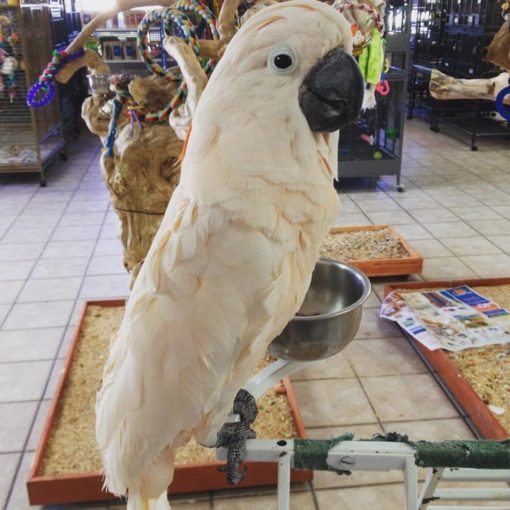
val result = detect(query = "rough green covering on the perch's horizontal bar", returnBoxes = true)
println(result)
[294,434,510,474]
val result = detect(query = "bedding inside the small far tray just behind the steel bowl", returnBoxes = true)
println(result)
[320,228,410,262]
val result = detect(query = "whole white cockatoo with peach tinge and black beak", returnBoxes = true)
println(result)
[96,0,363,509]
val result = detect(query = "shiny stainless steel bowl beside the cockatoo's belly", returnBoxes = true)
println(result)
[269,259,370,361]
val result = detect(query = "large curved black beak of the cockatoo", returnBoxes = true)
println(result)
[299,48,364,133]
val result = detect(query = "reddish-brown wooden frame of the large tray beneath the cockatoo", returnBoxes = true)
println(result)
[27,299,313,505]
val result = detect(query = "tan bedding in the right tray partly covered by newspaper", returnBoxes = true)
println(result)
[399,285,510,435]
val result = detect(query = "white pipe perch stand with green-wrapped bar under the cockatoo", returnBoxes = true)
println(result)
[217,434,510,510]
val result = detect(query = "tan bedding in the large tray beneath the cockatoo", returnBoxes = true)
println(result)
[39,306,297,476]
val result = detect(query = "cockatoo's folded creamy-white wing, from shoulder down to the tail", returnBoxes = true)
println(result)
[97,188,294,497]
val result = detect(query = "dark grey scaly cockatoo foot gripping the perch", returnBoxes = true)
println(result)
[217,389,258,485]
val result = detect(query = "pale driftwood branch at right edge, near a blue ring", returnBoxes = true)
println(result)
[429,69,510,104]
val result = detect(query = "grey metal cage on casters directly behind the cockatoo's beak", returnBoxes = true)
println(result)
[338,1,410,191]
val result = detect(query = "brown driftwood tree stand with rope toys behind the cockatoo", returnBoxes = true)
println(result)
[77,0,262,281]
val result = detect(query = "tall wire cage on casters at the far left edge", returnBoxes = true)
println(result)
[0,4,65,185]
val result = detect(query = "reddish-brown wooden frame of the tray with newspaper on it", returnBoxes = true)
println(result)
[384,277,510,439]
